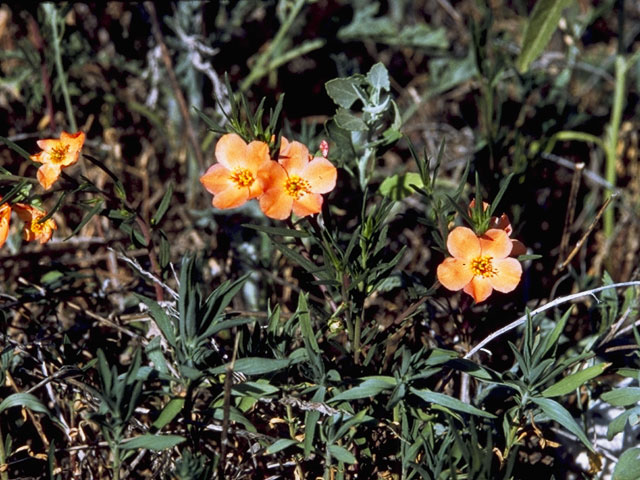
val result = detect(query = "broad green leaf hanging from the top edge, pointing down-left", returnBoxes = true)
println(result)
[516,0,572,73]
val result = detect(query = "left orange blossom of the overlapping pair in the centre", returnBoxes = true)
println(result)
[200,133,272,209]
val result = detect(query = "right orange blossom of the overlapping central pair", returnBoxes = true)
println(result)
[260,137,338,220]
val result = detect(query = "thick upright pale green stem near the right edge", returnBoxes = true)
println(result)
[604,55,627,237]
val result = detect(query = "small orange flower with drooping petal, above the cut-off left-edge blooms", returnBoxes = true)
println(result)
[31,132,84,190]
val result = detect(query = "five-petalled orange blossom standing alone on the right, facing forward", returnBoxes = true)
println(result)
[437,227,522,303]
